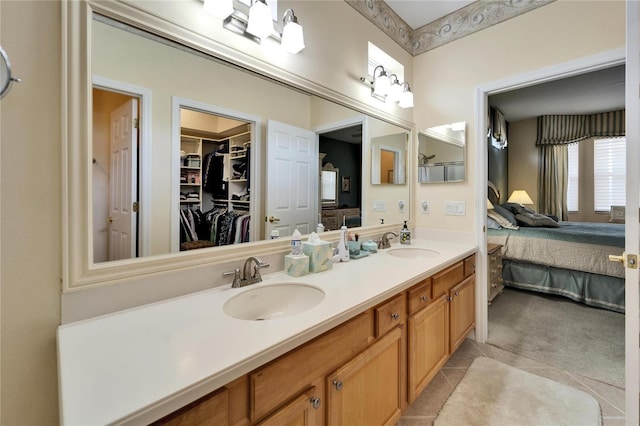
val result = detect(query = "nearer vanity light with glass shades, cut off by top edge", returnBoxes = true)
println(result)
[203,0,305,54]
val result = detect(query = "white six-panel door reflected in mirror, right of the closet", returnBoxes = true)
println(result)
[265,120,319,238]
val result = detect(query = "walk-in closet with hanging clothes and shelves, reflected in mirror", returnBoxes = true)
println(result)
[179,107,252,251]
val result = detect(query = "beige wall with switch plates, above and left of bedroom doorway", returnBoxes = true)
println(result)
[412,0,625,232]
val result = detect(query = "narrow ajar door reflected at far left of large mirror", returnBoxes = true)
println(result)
[107,99,138,260]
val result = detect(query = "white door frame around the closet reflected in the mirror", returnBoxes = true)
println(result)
[170,96,262,253]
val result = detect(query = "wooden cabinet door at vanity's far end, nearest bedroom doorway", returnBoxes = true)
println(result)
[449,275,476,353]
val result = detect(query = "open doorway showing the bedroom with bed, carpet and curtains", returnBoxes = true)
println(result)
[478,59,626,419]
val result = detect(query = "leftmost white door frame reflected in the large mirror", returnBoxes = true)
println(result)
[89,75,152,263]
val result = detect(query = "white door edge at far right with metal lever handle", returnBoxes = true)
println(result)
[625,1,640,425]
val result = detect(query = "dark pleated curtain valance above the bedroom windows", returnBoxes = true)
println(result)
[536,109,625,145]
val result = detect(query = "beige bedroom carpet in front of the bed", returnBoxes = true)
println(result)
[487,287,624,389]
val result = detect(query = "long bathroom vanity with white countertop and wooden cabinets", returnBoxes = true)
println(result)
[58,240,476,425]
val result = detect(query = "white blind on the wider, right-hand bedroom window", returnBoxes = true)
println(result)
[593,138,627,212]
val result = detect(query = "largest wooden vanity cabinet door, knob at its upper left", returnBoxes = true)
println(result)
[327,327,403,426]
